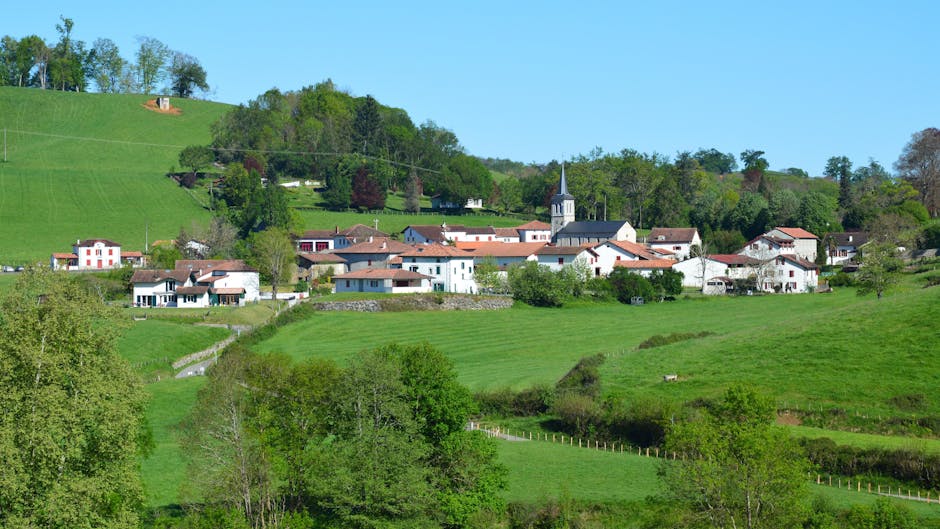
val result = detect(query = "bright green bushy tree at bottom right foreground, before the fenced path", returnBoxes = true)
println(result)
[660,386,808,529]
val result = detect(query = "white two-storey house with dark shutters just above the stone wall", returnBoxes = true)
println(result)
[399,244,478,294]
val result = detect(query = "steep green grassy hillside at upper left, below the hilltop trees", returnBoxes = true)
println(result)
[0,87,230,264]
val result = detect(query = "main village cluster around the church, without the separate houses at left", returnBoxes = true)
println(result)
[296,169,865,294]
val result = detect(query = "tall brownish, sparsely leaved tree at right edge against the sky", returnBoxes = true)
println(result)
[894,127,940,217]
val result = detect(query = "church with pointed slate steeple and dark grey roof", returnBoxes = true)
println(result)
[552,165,636,246]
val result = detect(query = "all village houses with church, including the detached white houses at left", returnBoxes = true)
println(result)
[50,169,867,307]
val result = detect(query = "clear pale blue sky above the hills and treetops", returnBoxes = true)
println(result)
[7,0,940,175]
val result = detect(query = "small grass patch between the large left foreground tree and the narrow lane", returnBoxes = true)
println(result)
[118,319,229,380]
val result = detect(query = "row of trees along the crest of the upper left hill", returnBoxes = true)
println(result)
[0,16,209,98]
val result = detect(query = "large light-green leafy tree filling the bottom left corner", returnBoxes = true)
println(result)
[0,268,149,528]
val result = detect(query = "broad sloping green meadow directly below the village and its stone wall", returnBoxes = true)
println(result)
[250,282,940,414]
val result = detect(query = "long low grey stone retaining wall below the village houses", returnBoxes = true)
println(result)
[313,294,512,312]
